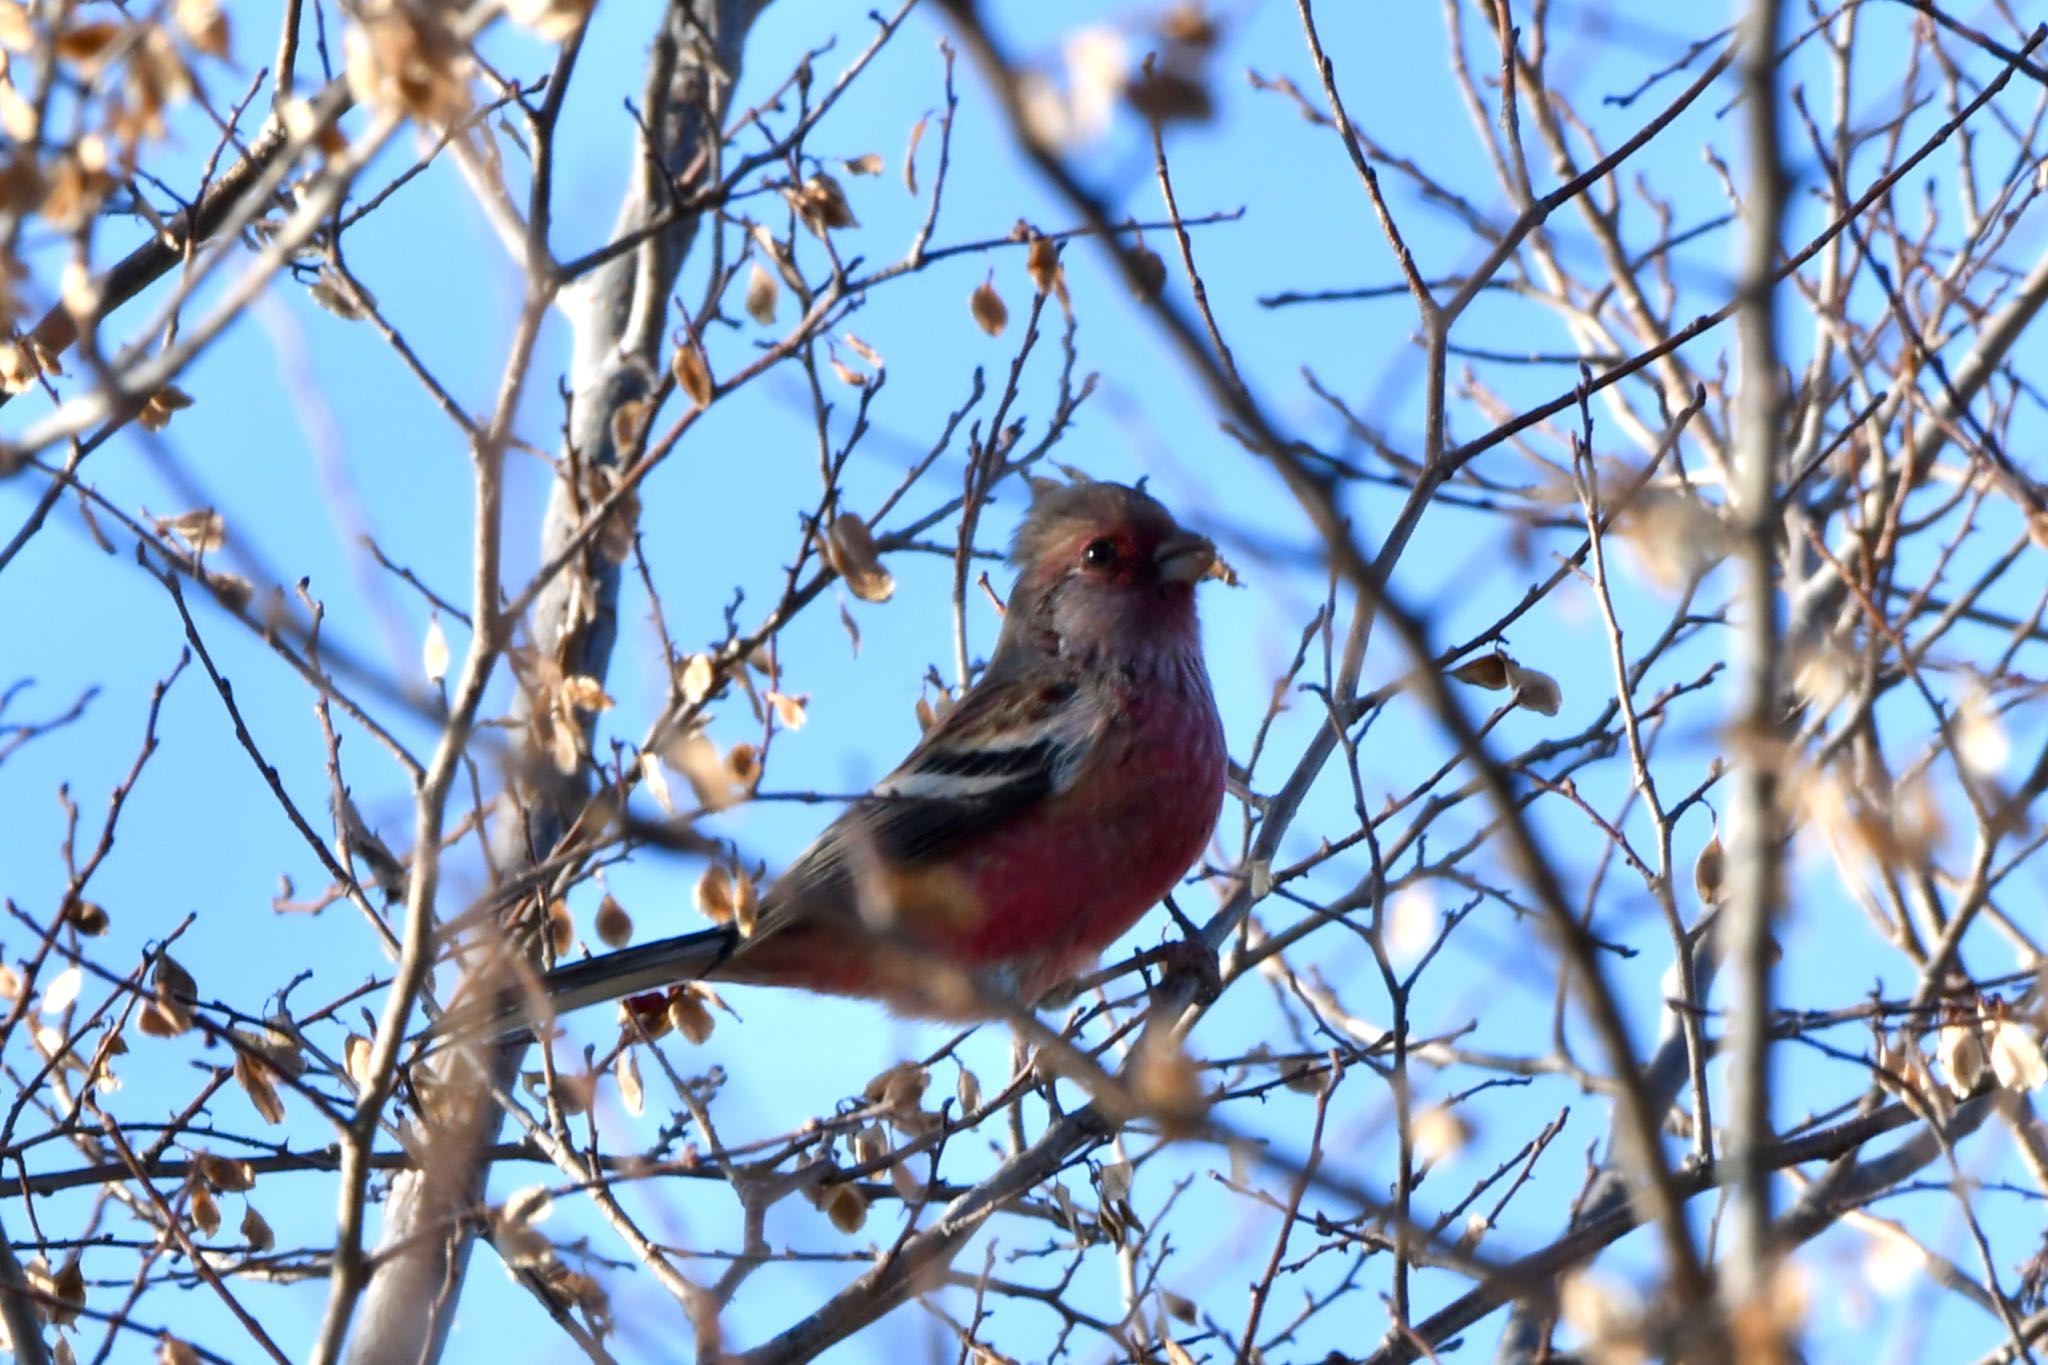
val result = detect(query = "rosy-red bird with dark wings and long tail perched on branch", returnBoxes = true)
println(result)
[524,483,1227,1017]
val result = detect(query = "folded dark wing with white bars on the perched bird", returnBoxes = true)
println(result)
[758,677,1104,935]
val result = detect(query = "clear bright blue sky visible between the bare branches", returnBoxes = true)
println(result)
[0,4,2044,1361]
